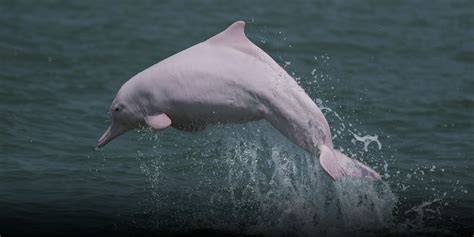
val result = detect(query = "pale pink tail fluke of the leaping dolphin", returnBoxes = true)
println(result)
[319,145,380,180]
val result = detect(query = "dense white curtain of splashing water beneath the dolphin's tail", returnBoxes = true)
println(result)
[218,126,396,235]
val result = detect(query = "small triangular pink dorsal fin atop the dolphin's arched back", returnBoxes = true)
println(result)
[208,21,253,48]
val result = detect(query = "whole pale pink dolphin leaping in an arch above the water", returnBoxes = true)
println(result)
[97,21,380,180]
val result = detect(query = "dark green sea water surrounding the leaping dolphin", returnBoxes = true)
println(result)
[0,0,474,236]
